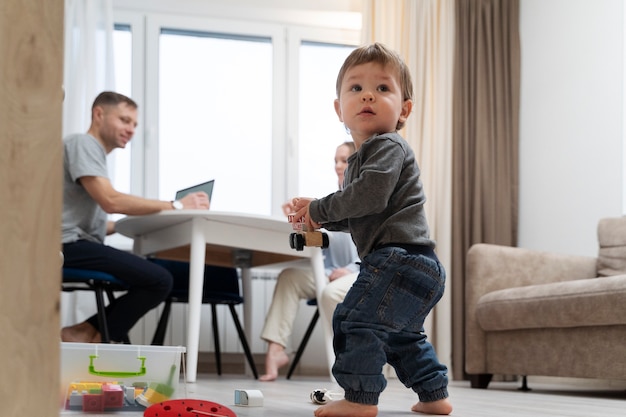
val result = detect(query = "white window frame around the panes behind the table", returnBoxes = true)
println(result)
[109,0,361,216]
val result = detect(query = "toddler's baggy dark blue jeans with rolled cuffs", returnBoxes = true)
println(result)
[333,247,448,405]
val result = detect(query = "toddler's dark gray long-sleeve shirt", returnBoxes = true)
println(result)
[309,132,435,259]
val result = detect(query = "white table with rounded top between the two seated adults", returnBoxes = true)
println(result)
[115,210,334,382]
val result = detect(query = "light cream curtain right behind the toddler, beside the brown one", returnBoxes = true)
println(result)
[363,0,454,376]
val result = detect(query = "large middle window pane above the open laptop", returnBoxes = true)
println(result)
[158,29,273,215]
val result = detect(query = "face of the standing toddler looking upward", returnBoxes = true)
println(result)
[335,62,411,141]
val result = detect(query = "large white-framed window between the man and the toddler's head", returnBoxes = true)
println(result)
[115,8,359,216]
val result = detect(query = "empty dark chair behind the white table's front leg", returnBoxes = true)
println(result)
[150,258,259,379]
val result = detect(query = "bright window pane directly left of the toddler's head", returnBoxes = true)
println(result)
[298,42,354,197]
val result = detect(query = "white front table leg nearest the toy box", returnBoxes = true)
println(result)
[187,218,206,382]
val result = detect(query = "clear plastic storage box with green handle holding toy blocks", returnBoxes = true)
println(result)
[60,343,185,414]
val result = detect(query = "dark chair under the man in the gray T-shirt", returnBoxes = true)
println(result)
[61,268,130,343]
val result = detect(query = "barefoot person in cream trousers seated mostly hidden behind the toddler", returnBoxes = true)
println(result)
[259,142,359,381]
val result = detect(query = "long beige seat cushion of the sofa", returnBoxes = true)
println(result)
[476,275,626,331]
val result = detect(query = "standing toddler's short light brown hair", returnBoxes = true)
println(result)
[336,42,413,129]
